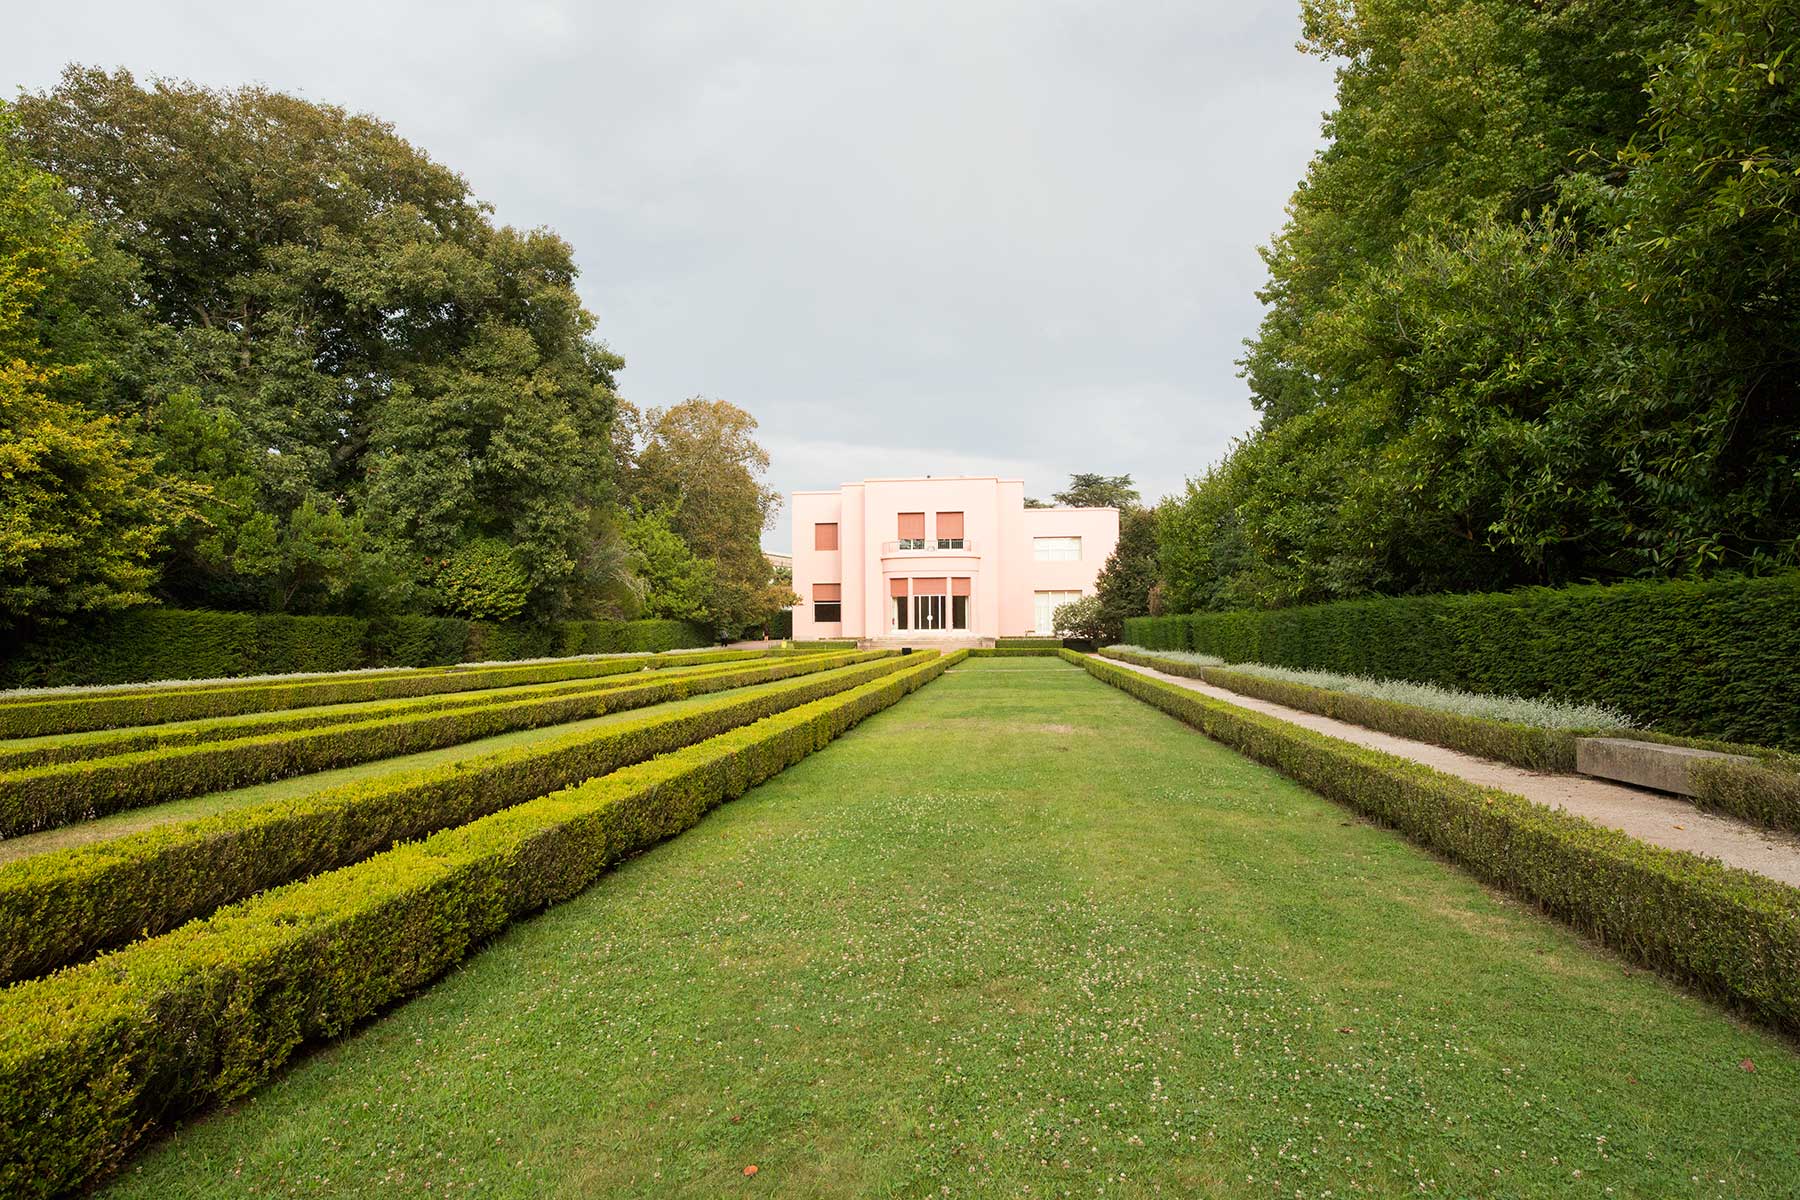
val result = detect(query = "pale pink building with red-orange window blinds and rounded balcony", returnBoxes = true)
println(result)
[790,475,1120,640]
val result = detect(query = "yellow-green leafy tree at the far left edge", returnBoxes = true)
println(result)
[0,106,193,630]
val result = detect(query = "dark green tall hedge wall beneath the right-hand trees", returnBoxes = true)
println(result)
[1125,572,1800,750]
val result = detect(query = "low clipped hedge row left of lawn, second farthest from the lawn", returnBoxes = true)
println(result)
[0,655,792,772]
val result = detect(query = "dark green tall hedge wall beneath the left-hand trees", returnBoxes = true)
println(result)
[0,608,713,687]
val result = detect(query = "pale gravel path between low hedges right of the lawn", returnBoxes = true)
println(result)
[1107,658,1800,885]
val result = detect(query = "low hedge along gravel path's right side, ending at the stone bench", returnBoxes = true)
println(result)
[1100,646,1575,772]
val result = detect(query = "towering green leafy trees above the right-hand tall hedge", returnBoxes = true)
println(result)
[1161,0,1800,608]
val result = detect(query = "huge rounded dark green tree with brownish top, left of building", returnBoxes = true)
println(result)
[13,68,625,615]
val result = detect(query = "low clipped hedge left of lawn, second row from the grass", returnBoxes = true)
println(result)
[0,657,911,982]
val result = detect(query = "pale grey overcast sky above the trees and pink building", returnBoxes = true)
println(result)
[10,0,1332,549]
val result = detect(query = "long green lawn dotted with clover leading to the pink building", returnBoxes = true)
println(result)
[108,658,1800,1200]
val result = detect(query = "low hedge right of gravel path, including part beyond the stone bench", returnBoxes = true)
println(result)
[1100,646,1800,833]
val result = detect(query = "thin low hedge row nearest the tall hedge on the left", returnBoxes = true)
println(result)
[0,649,769,738]
